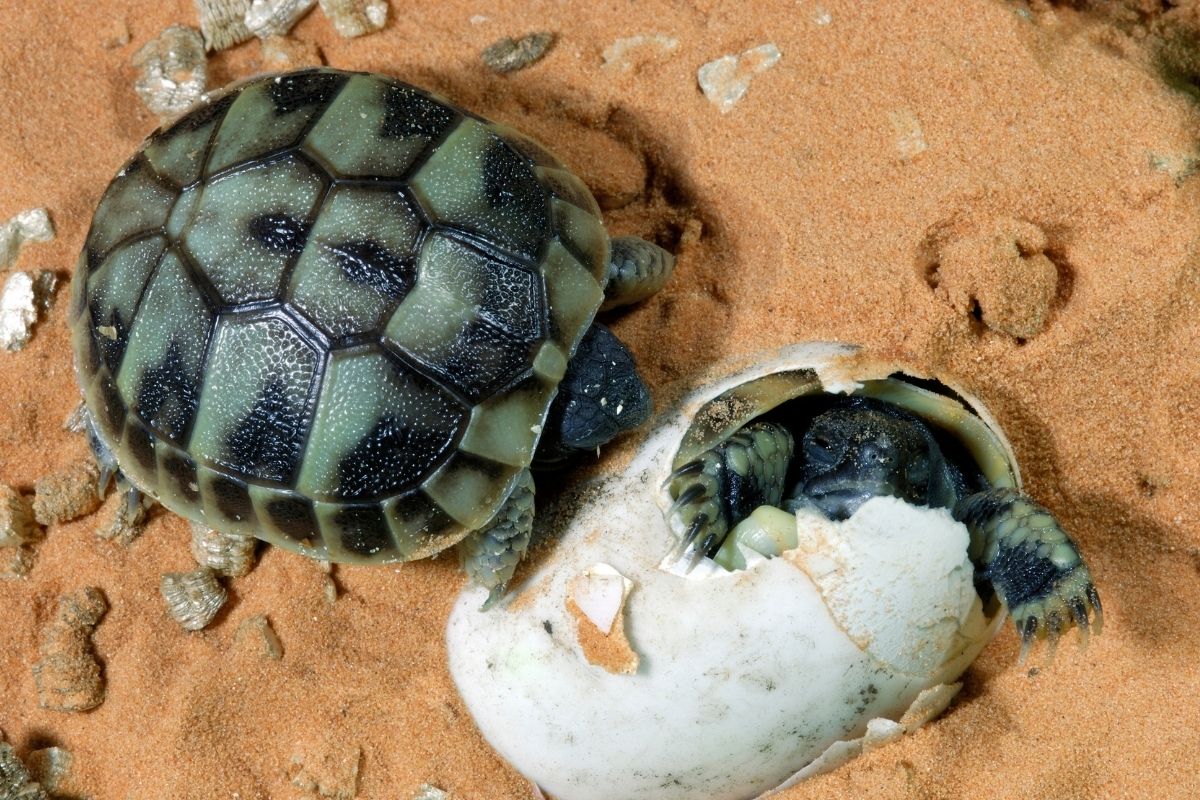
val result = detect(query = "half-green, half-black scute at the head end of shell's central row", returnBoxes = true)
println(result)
[385,234,545,403]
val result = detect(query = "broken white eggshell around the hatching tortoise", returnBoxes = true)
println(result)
[446,343,1015,800]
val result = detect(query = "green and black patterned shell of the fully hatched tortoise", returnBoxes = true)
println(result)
[71,70,608,563]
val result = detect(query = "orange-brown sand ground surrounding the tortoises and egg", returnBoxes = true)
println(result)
[0,0,1200,800]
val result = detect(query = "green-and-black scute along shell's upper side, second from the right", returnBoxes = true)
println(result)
[304,76,460,180]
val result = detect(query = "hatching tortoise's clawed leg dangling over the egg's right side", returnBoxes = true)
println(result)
[954,488,1103,660]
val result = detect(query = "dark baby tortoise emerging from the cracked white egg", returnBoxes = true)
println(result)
[668,372,1102,658]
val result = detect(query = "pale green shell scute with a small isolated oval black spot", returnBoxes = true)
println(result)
[184,157,324,305]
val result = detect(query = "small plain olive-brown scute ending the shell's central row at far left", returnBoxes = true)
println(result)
[86,154,179,255]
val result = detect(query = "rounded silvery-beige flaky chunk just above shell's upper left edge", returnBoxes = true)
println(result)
[133,25,208,121]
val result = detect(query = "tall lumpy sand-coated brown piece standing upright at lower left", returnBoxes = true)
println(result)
[34,587,108,711]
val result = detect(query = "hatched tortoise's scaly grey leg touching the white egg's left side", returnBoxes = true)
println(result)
[458,469,534,610]
